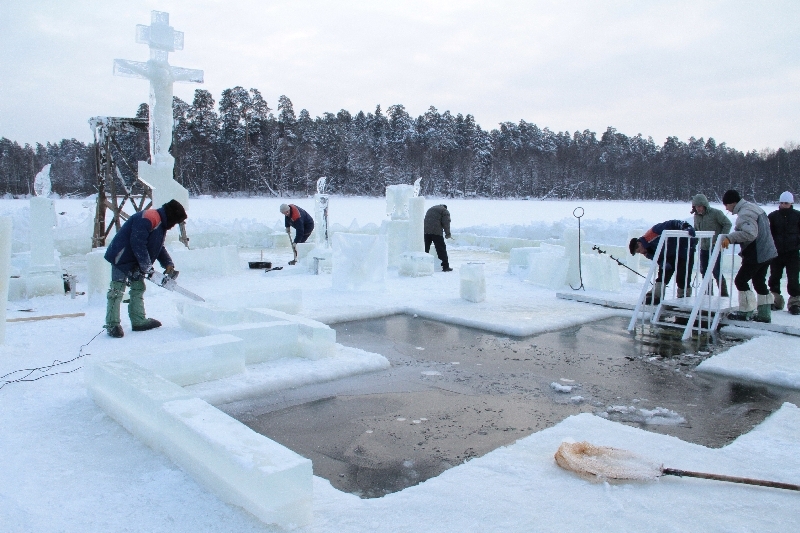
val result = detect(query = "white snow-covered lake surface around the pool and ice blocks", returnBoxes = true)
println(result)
[0,196,800,532]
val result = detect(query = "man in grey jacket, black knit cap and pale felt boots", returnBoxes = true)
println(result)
[722,189,778,323]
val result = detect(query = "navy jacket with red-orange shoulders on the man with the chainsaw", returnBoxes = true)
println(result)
[104,207,174,275]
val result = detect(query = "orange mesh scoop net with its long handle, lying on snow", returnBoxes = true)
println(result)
[555,441,800,491]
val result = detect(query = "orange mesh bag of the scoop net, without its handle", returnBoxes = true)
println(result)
[555,441,662,482]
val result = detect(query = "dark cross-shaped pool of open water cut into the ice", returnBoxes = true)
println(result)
[219,315,800,498]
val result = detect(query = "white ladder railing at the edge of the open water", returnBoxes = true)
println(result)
[628,230,735,340]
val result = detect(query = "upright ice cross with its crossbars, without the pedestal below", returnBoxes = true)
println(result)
[114,11,203,166]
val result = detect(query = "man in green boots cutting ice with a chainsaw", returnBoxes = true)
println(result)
[105,200,186,338]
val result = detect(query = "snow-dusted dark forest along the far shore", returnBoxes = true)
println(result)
[0,87,800,203]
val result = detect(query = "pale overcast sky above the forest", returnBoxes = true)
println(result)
[0,0,800,151]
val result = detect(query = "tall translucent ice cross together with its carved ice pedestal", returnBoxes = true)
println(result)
[114,11,203,210]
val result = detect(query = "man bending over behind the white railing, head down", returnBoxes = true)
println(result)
[628,220,697,304]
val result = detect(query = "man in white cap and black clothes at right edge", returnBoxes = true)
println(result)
[769,191,800,315]
